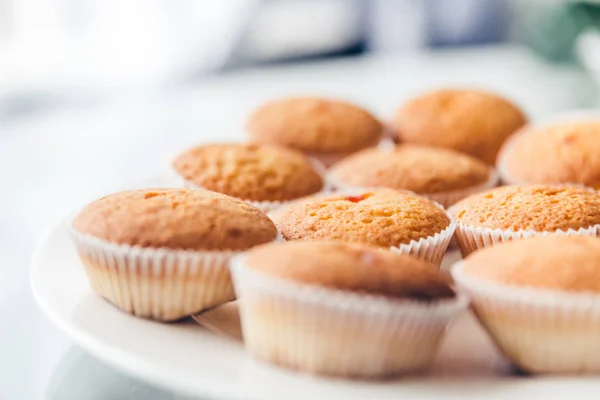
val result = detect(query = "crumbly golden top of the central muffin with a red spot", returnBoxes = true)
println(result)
[272,189,450,248]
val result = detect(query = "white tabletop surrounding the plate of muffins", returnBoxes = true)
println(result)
[0,48,595,400]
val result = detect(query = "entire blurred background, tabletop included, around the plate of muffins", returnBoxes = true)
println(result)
[0,0,600,399]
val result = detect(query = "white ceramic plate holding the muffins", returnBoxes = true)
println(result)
[29,222,600,399]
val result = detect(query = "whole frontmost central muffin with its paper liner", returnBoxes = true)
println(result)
[232,241,467,378]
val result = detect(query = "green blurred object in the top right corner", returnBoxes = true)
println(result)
[527,1,600,62]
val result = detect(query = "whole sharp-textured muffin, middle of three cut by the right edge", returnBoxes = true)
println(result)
[448,185,600,255]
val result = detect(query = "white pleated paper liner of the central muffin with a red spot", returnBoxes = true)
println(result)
[269,187,456,266]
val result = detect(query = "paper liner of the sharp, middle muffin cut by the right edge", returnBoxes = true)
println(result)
[450,219,600,257]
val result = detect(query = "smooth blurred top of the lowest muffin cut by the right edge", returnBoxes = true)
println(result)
[462,236,600,292]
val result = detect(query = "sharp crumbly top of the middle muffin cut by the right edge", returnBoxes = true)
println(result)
[449,185,600,232]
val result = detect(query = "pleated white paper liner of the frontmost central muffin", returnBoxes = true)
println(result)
[232,257,468,378]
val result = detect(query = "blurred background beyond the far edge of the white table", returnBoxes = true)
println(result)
[0,0,600,119]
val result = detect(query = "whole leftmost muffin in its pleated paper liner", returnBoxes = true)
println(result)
[71,189,277,321]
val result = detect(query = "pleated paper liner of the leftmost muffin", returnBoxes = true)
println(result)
[70,228,239,321]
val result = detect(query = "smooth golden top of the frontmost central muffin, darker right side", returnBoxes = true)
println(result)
[246,241,454,301]
